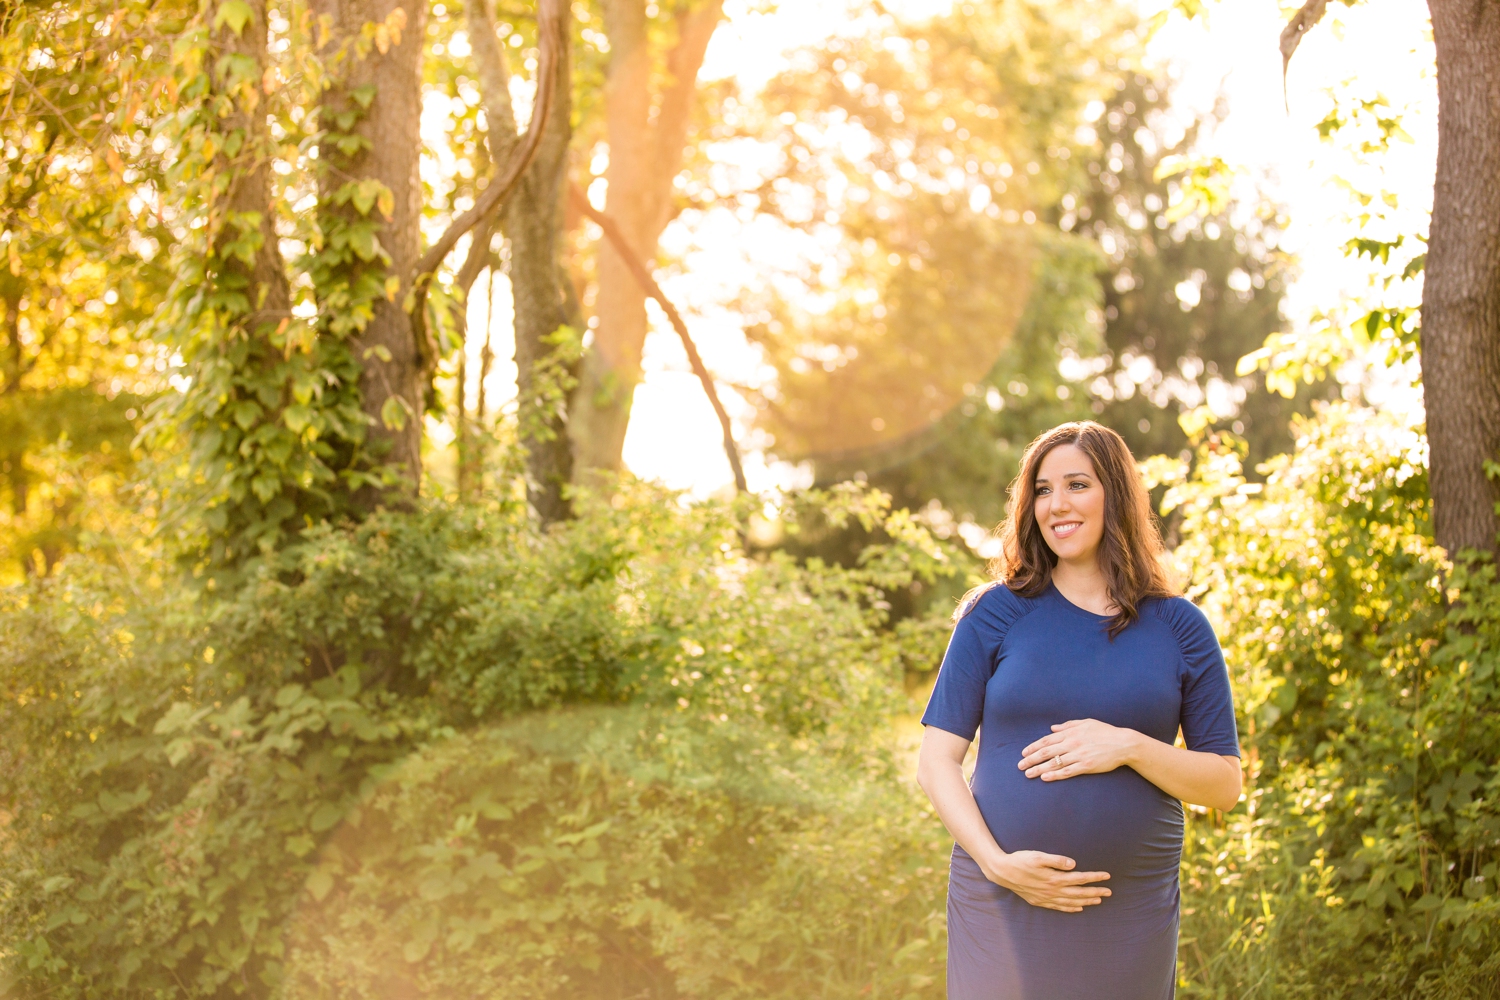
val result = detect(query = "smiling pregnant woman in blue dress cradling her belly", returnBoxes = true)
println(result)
[918,421,1241,1000]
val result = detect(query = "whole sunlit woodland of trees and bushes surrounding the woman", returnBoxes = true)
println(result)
[0,0,1500,999]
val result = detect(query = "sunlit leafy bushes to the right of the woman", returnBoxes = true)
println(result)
[1158,405,1500,997]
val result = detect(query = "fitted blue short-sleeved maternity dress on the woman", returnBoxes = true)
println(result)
[923,585,1239,1000]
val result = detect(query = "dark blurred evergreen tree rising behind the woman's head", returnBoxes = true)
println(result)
[1074,74,1320,469]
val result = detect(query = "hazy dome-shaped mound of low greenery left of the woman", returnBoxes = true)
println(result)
[287,706,947,999]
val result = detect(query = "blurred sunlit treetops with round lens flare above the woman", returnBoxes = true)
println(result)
[702,3,1328,523]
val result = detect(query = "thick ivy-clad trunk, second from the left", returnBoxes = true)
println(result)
[312,0,432,494]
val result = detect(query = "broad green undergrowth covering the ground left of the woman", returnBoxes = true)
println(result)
[0,486,963,996]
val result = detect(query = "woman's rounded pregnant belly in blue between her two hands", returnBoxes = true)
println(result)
[972,738,1182,895]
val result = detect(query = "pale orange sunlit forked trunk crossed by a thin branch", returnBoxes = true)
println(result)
[569,0,723,472]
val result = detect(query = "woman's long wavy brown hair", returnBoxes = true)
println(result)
[954,420,1178,637]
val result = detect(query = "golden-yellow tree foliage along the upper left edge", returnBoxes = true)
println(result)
[0,3,177,582]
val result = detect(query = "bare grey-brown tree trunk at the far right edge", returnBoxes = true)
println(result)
[1422,0,1500,556]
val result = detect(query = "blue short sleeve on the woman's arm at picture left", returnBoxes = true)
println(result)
[923,585,1025,739]
